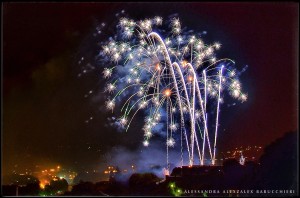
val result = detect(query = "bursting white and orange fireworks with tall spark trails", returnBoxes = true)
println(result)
[101,16,247,165]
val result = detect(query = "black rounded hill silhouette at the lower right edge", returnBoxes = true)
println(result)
[257,131,298,189]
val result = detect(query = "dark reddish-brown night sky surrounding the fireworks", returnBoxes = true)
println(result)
[2,3,299,173]
